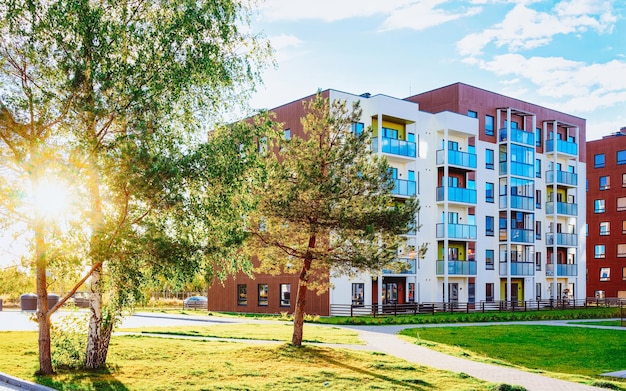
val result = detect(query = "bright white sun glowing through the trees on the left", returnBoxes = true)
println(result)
[33,178,72,220]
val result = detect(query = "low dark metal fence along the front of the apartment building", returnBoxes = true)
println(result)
[330,298,626,318]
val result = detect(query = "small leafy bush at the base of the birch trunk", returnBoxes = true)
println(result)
[50,313,88,369]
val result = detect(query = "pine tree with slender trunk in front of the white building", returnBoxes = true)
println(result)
[249,93,418,346]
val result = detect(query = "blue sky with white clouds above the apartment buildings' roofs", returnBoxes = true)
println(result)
[251,0,626,140]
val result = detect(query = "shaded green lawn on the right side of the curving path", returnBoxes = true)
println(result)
[401,325,626,389]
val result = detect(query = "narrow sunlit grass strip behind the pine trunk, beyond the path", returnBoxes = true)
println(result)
[120,323,363,345]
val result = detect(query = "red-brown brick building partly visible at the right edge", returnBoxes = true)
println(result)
[587,127,626,299]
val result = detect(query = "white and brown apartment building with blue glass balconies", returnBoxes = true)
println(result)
[209,83,586,315]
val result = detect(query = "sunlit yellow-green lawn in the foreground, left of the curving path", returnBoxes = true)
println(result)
[0,332,505,391]
